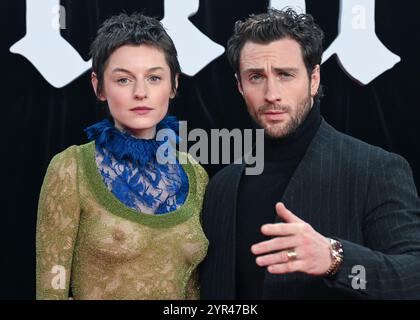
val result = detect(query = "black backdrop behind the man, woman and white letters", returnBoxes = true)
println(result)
[0,0,420,299]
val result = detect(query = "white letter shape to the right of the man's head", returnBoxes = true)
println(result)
[322,0,401,85]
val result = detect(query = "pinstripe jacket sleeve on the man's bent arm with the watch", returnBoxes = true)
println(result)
[326,154,420,299]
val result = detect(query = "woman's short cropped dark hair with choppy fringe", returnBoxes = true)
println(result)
[90,13,181,95]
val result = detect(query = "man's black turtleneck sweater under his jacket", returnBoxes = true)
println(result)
[236,103,321,299]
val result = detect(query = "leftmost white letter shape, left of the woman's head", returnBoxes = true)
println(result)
[10,0,91,88]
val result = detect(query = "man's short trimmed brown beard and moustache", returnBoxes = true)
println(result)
[248,94,312,138]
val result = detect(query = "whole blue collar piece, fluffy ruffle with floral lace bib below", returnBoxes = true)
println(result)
[85,116,189,214]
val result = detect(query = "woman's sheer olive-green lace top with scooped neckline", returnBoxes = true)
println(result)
[36,142,208,299]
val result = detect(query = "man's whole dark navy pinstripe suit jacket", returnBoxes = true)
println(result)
[200,120,420,299]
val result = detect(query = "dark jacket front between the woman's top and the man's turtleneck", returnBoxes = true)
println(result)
[200,164,245,299]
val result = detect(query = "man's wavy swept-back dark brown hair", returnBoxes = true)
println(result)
[226,8,324,98]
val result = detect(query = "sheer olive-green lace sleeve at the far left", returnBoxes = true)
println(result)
[36,146,80,299]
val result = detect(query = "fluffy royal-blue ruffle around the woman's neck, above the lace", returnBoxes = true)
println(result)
[84,115,179,167]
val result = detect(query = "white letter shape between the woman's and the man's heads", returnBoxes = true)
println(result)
[162,0,225,76]
